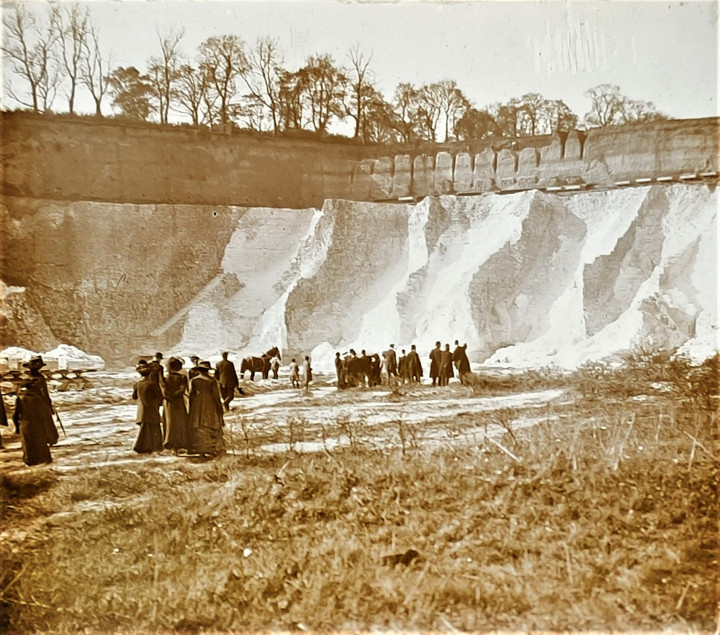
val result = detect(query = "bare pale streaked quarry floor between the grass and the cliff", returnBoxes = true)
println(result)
[0,373,573,474]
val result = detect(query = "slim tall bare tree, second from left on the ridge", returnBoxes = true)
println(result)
[50,2,90,113]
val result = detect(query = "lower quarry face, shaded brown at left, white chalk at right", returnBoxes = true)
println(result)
[2,183,718,371]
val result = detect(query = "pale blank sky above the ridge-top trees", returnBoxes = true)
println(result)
[3,0,719,118]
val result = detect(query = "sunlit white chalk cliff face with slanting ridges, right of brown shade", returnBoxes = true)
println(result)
[173,184,718,370]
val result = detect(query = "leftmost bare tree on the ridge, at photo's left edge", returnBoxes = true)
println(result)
[1,2,59,112]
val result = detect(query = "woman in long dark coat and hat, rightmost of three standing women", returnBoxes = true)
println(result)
[190,361,225,456]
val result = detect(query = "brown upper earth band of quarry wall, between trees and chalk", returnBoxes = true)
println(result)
[0,113,719,208]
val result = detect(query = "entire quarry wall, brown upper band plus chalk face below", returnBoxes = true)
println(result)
[0,113,718,368]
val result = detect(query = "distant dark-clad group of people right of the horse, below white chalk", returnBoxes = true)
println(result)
[335,340,471,388]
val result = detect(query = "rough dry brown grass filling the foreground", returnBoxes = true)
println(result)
[0,350,719,632]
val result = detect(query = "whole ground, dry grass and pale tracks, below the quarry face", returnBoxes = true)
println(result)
[0,372,718,632]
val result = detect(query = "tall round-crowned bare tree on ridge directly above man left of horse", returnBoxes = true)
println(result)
[200,35,249,123]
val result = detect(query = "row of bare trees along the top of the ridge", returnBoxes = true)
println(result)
[2,2,666,143]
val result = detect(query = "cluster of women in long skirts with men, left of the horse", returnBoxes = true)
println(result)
[132,352,248,456]
